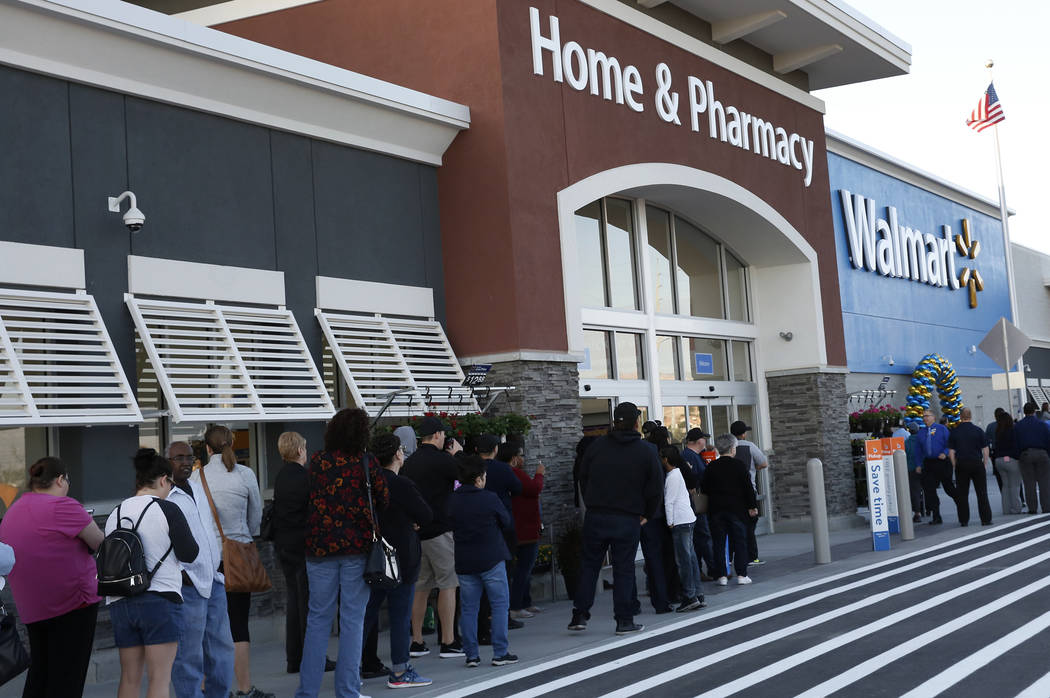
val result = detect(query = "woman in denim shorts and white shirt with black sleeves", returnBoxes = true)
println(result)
[108,448,198,698]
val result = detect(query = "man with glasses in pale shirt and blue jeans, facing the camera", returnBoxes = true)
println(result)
[165,441,233,698]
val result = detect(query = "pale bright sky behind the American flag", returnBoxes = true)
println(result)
[815,0,1050,254]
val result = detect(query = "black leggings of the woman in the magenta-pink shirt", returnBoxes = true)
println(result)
[22,604,99,698]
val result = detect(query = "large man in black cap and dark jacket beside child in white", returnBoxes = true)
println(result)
[569,402,664,635]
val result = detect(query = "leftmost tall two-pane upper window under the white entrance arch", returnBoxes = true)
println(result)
[575,198,638,310]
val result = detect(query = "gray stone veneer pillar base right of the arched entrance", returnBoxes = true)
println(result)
[767,372,857,530]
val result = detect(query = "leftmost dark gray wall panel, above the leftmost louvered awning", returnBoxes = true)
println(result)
[0,66,74,247]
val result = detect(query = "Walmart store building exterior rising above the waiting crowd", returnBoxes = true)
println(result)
[0,0,1050,545]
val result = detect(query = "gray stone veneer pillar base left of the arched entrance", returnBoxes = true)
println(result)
[483,360,583,535]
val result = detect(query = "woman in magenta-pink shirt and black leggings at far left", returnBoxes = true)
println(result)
[0,458,103,698]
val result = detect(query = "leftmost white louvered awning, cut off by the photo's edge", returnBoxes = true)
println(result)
[0,289,142,426]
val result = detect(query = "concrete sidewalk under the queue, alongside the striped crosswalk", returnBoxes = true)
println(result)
[0,470,1025,698]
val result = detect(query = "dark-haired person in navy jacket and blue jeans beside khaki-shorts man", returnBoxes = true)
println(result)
[448,456,518,667]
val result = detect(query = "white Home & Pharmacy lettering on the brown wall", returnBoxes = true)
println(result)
[529,7,814,187]
